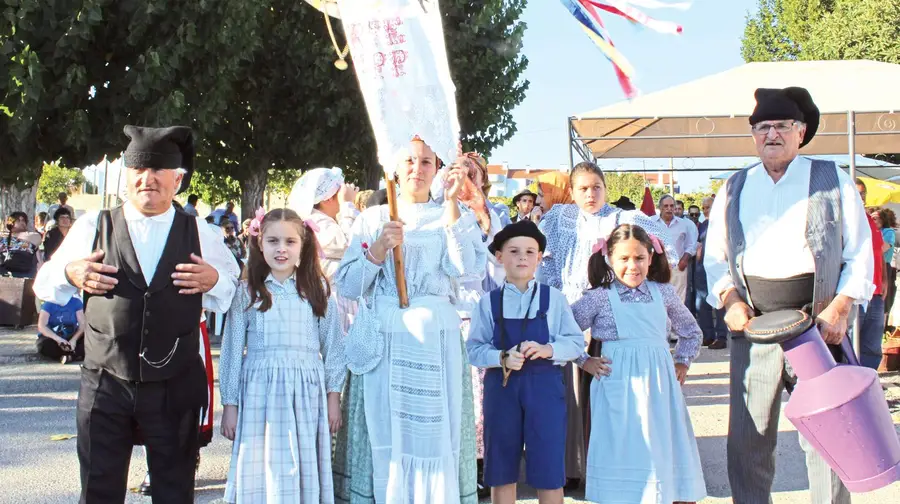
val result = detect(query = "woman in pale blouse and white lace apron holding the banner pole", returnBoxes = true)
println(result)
[334,138,486,504]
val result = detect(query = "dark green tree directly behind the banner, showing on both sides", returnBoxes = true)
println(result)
[201,0,528,217]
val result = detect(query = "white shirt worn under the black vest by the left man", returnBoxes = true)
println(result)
[34,202,240,313]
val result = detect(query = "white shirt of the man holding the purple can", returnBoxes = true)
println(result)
[703,157,875,308]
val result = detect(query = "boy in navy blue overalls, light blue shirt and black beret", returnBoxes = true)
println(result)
[466,220,608,504]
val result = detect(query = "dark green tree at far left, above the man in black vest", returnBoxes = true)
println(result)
[0,0,262,220]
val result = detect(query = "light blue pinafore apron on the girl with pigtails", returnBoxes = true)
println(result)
[585,282,706,504]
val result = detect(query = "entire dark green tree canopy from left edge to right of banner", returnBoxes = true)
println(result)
[0,0,528,220]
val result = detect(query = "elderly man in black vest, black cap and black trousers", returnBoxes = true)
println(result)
[34,126,238,504]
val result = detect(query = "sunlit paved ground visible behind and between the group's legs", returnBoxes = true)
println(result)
[0,328,900,504]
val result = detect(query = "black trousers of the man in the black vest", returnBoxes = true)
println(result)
[77,368,206,504]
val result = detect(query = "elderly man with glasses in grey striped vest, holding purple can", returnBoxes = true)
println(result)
[704,87,874,504]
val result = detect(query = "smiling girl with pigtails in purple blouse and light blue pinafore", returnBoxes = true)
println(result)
[573,224,706,504]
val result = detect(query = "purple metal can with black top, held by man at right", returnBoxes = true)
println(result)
[744,310,900,492]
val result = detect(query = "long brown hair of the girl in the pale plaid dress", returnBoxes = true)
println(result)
[244,208,331,317]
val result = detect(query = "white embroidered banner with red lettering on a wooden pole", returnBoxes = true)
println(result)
[337,0,459,174]
